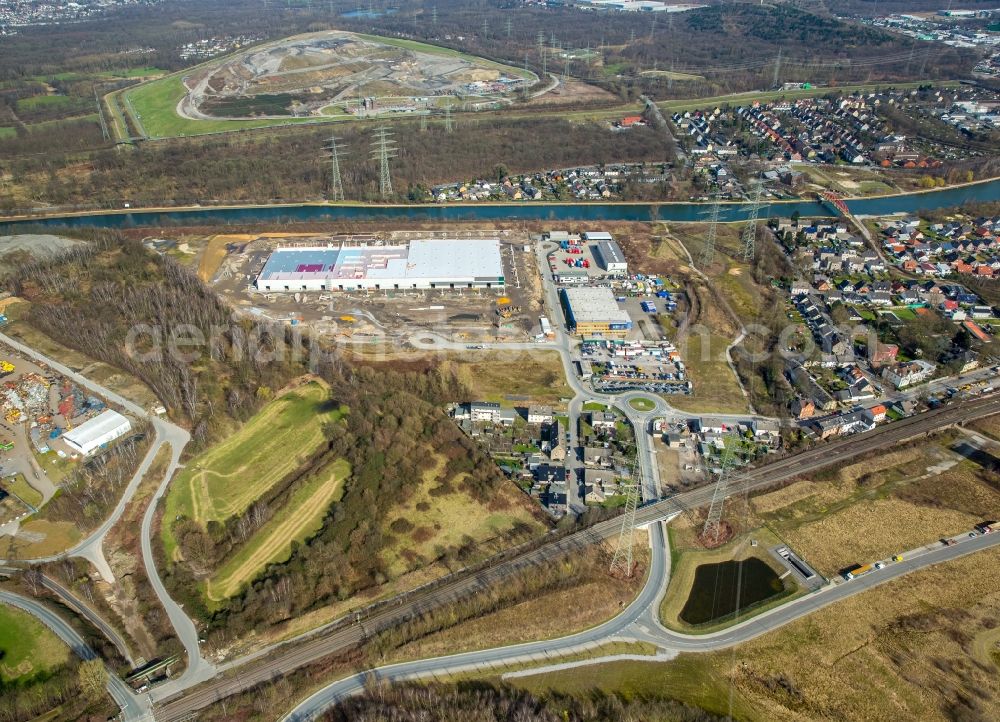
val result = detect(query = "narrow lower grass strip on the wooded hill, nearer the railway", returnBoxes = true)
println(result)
[205,460,351,601]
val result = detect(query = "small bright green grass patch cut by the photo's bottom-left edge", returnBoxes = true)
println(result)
[0,605,70,684]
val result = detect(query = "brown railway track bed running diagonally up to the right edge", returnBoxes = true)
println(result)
[156,395,1000,722]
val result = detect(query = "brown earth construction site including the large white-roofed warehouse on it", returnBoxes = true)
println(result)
[202,230,543,345]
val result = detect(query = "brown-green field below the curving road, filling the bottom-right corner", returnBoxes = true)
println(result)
[506,548,1000,722]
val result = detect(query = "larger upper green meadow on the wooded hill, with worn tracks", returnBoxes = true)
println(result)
[163,381,346,559]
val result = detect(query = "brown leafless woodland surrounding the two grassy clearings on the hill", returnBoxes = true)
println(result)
[6,232,545,638]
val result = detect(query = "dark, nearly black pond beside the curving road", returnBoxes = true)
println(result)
[680,557,784,624]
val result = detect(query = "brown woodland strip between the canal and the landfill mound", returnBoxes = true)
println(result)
[0,116,673,212]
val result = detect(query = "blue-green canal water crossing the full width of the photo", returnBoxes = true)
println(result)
[0,178,1000,233]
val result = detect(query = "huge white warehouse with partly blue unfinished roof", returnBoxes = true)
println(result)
[255,238,505,292]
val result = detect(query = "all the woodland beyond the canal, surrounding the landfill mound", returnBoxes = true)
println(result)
[0,0,973,213]
